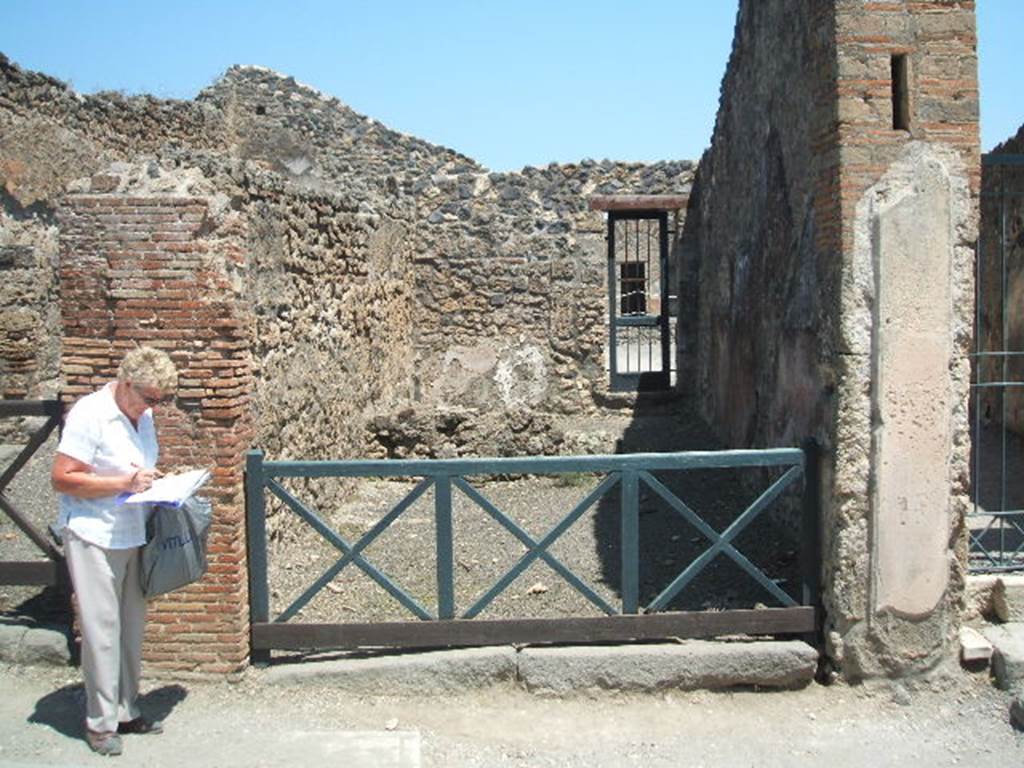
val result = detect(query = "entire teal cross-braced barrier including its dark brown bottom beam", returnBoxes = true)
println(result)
[246,445,819,662]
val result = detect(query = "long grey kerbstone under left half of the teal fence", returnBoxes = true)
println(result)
[265,646,516,695]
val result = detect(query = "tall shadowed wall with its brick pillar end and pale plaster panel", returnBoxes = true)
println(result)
[690,0,979,678]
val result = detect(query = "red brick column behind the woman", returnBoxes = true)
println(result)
[60,195,253,673]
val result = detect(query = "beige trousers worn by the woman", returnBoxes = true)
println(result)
[63,528,145,732]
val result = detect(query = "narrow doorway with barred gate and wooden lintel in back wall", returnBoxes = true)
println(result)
[591,195,686,392]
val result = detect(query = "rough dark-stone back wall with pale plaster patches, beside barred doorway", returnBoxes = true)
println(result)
[199,67,693,457]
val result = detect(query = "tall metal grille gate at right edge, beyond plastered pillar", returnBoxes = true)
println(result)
[968,155,1024,572]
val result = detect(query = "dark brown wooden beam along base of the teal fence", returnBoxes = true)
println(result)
[252,605,816,650]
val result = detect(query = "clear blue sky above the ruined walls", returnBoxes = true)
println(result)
[0,0,1024,170]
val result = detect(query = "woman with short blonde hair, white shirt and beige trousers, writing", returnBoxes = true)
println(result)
[51,347,177,755]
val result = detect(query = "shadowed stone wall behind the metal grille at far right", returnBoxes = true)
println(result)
[975,128,1024,435]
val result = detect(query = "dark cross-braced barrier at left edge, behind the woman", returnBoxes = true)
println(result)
[0,400,65,586]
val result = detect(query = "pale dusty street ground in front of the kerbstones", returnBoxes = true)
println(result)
[0,667,1024,768]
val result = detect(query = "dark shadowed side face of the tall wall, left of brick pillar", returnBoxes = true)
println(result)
[687,0,838,446]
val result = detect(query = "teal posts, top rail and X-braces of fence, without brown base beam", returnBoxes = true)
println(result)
[246,443,819,659]
